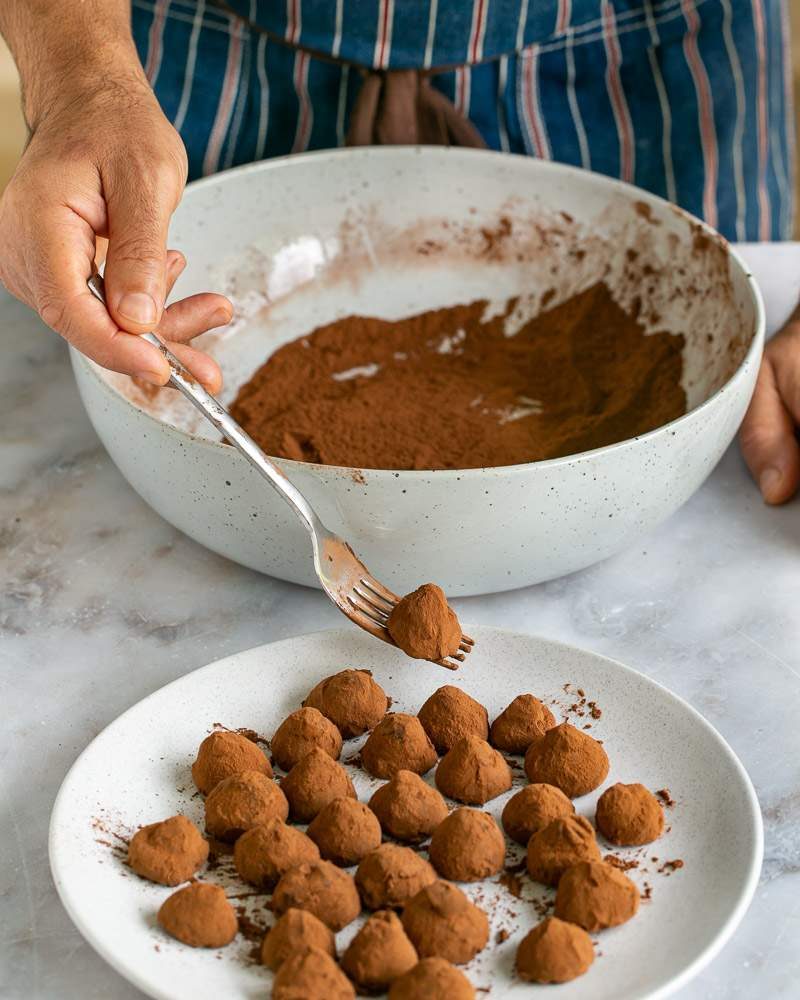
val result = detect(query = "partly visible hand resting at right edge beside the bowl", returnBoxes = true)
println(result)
[739,309,800,504]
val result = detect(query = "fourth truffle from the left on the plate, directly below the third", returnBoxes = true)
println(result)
[206,771,289,841]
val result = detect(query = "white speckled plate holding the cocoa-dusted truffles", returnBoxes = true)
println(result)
[50,628,763,1000]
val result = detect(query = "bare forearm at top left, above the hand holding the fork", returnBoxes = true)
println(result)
[0,0,146,130]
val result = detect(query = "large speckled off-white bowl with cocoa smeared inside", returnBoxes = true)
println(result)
[73,148,764,596]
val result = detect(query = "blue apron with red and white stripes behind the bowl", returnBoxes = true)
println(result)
[133,0,794,240]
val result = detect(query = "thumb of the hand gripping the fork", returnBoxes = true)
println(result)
[104,166,177,333]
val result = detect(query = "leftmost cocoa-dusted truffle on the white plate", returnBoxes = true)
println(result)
[128,816,208,885]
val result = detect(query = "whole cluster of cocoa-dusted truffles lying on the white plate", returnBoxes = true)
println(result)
[129,670,663,1000]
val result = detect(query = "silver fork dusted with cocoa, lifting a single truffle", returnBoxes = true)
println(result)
[88,274,474,670]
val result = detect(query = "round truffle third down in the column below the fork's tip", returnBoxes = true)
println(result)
[428,809,506,882]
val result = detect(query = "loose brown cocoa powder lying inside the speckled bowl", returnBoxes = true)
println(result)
[232,283,686,469]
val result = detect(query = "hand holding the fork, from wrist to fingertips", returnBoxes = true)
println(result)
[0,76,233,392]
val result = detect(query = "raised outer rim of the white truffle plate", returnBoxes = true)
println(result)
[47,624,764,1000]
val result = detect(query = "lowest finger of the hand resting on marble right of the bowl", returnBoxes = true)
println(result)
[739,356,800,504]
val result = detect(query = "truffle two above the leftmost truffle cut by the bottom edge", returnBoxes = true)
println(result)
[270,861,361,931]
